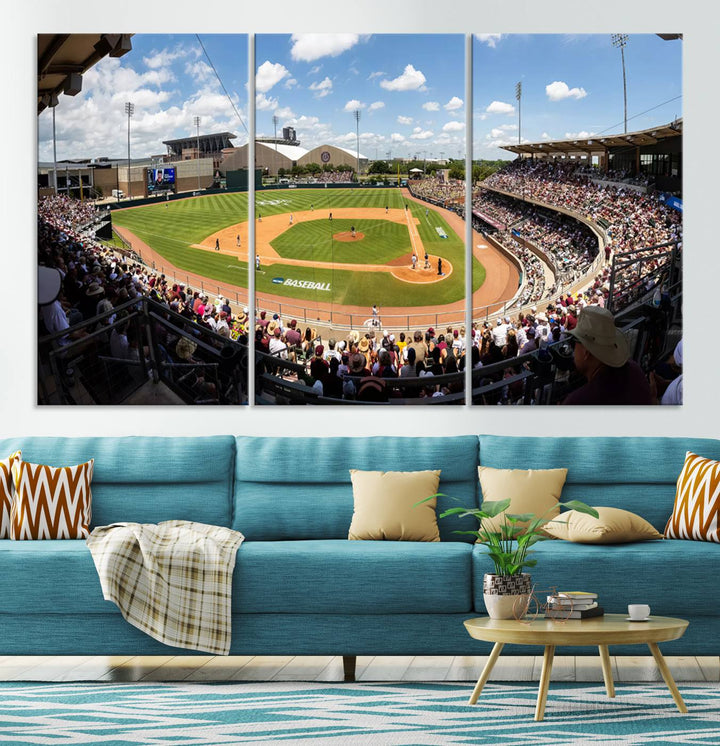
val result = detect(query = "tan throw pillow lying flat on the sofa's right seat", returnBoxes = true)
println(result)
[545,507,663,544]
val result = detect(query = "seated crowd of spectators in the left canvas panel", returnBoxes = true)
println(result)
[38,196,248,396]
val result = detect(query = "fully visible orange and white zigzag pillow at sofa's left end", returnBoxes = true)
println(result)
[10,459,95,539]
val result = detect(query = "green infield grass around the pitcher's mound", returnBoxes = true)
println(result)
[270,217,412,264]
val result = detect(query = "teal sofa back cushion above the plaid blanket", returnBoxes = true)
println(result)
[0,435,235,529]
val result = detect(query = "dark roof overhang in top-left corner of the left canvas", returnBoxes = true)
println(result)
[38,34,133,114]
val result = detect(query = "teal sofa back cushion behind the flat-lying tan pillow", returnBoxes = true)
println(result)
[480,435,720,532]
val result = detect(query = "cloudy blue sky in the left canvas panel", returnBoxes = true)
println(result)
[38,34,248,161]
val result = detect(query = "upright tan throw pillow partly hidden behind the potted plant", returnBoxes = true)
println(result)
[478,466,567,531]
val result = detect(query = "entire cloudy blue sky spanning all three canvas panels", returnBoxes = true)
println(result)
[38,33,683,161]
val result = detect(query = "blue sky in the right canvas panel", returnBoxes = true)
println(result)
[473,34,684,158]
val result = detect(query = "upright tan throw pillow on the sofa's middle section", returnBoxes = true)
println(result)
[348,469,440,541]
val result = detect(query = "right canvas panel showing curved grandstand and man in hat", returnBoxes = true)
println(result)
[472,33,684,406]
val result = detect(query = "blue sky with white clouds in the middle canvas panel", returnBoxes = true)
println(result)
[255,34,465,159]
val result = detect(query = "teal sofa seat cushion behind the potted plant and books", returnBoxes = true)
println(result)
[473,539,720,618]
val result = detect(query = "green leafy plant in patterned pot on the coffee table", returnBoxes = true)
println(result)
[421,494,598,619]
